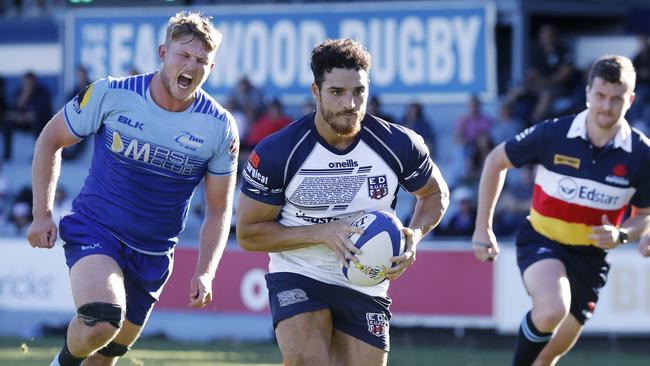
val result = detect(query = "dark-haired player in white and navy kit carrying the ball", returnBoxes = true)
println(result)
[237,39,449,366]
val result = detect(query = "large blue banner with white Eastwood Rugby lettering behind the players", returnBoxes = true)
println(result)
[65,1,496,103]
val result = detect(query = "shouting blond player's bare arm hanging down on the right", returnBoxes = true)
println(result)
[189,173,236,308]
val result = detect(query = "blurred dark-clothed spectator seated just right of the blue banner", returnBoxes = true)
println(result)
[507,24,579,124]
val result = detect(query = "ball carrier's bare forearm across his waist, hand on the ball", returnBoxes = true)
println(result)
[237,193,363,265]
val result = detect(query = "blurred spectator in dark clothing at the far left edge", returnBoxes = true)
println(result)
[3,72,52,160]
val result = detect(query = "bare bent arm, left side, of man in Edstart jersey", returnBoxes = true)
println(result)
[472,143,512,262]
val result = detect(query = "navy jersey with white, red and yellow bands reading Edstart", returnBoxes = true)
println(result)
[505,111,650,245]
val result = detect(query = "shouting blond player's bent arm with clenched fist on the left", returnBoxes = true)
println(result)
[27,111,79,248]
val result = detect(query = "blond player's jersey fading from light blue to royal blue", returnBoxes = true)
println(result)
[64,73,238,252]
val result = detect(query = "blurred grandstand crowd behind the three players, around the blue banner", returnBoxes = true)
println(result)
[0,0,650,244]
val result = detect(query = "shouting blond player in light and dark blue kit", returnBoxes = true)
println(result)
[28,12,239,366]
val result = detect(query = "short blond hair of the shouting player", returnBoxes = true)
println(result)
[165,11,223,52]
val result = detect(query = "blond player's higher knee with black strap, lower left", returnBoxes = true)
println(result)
[77,302,125,344]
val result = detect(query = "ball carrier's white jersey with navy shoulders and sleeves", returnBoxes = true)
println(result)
[241,113,434,296]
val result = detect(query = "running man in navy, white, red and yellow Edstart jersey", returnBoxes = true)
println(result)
[472,55,650,366]
